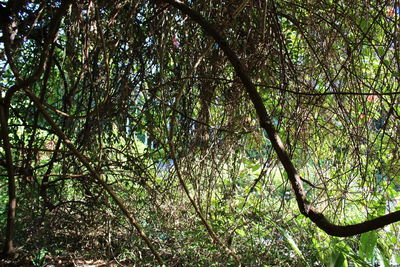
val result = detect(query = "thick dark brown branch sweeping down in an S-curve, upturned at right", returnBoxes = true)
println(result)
[162,0,400,237]
